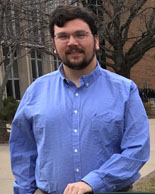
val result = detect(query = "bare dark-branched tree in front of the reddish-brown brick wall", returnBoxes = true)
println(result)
[82,0,155,78]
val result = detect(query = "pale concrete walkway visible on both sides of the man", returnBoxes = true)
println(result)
[0,119,155,194]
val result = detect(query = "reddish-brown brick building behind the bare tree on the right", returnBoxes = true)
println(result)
[107,0,155,89]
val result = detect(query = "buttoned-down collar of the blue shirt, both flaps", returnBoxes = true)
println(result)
[58,62,101,87]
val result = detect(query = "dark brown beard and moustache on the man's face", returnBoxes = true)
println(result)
[57,41,96,70]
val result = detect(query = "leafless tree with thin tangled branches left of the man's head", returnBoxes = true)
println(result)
[0,0,54,108]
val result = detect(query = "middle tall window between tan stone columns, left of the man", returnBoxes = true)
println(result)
[31,50,43,80]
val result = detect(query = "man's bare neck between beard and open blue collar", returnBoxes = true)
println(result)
[63,58,97,87]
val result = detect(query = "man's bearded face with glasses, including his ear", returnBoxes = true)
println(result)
[54,19,99,70]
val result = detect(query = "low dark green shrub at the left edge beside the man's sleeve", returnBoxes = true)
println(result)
[0,97,19,122]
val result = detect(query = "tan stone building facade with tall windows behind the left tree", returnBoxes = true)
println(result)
[0,0,60,100]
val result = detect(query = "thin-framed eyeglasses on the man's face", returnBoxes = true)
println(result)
[54,30,92,43]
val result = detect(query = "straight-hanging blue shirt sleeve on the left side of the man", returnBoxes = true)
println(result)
[10,93,37,194]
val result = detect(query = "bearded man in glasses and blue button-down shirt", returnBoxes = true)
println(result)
[10,6,149,194]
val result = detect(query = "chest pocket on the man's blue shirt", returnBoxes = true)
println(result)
[91,112,123,148]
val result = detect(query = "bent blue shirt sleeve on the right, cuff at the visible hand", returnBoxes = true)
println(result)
[82,82,150,192]
